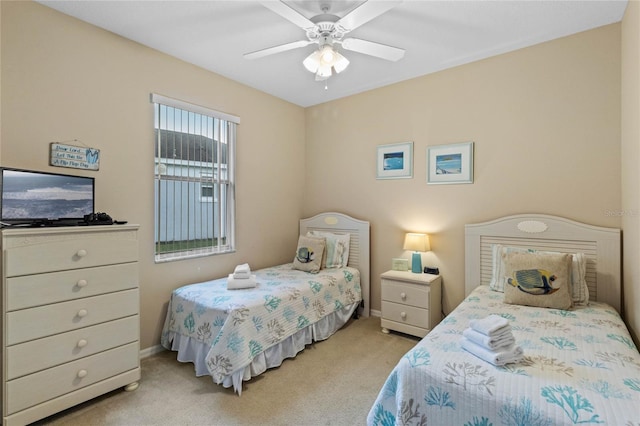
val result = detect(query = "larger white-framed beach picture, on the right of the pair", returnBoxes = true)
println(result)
[427,142,473,184]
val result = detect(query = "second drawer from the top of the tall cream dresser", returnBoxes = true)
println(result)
[6,263,138,311]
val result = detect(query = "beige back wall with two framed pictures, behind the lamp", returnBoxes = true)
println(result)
[304,24,621,313]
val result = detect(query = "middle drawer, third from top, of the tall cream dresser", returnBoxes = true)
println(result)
[6,289,139,345]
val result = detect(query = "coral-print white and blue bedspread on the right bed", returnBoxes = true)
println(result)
[367,286,640,426]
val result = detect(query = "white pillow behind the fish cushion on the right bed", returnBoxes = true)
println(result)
[489,244,589,305]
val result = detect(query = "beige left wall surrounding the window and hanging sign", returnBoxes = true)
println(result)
[0,2,305,348]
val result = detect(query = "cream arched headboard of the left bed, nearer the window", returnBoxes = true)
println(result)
[300,212,371,317]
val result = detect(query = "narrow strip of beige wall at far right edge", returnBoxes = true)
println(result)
[621,1,640,345]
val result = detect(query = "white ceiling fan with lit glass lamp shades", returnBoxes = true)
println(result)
[244,0,404,81]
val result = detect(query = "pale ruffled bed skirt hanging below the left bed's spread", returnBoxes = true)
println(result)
[164,302,360,395]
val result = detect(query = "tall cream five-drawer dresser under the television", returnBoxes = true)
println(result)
[1,225,140,426]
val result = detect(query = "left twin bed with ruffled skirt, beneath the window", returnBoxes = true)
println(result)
[161,212,370,394]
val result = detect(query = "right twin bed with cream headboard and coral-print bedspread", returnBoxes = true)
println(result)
[367,215,640,426]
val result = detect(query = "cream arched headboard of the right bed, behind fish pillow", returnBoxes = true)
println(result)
[465,214,622,312]
